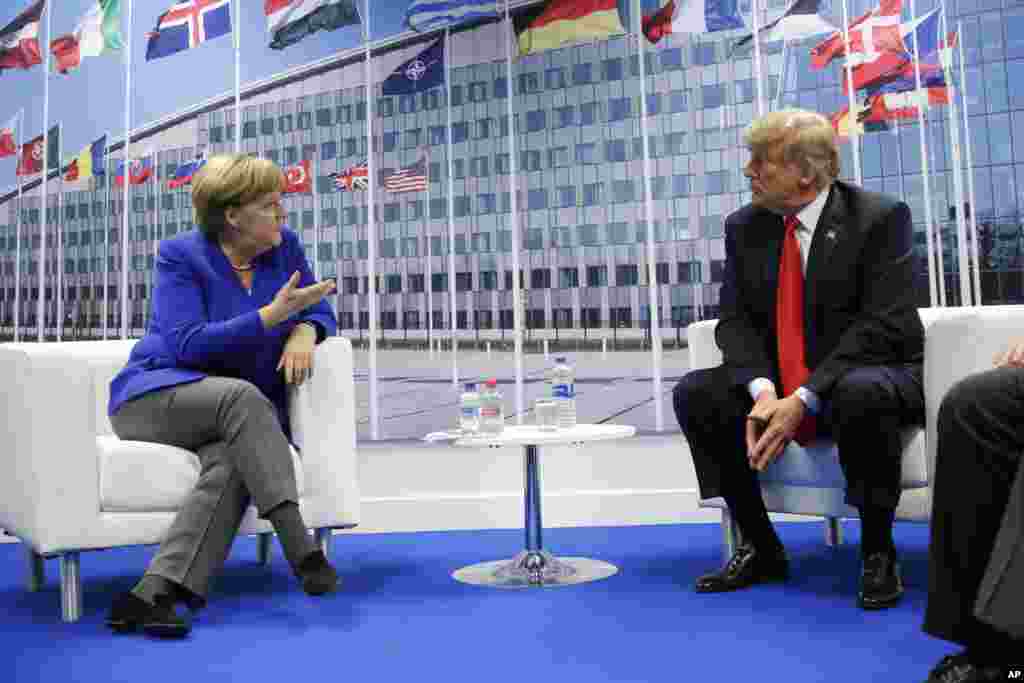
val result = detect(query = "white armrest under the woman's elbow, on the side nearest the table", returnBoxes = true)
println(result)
[289,337,359,523]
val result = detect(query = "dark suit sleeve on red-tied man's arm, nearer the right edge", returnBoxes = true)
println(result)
[805,202,925,395]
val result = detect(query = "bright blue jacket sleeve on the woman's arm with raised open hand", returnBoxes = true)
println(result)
[154,241,267,370]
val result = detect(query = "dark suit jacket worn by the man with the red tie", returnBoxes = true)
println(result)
[715,181,925,398]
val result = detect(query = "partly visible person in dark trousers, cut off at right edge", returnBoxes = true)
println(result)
[924,350,1024,683]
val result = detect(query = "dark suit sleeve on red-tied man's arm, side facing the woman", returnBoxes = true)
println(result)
[715,218,775,386]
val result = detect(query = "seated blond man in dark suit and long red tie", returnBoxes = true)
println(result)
[673,110,925,609]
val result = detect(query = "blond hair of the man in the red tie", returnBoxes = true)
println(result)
[743,109,840,189]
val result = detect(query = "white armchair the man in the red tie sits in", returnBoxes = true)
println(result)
[687,306,1024,558]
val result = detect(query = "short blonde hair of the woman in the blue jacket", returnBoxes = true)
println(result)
[193,155,285,242]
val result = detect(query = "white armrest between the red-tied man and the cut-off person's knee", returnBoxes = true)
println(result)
[924,306,1024,481]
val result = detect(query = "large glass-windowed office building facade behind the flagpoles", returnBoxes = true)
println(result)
[0,0,1024,339]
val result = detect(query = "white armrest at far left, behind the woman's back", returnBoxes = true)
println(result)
[0,344,107,553]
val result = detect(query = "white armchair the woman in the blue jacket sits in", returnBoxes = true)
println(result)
[0,337,359,622]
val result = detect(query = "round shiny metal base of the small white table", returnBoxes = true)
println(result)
[452,550,618,588]
